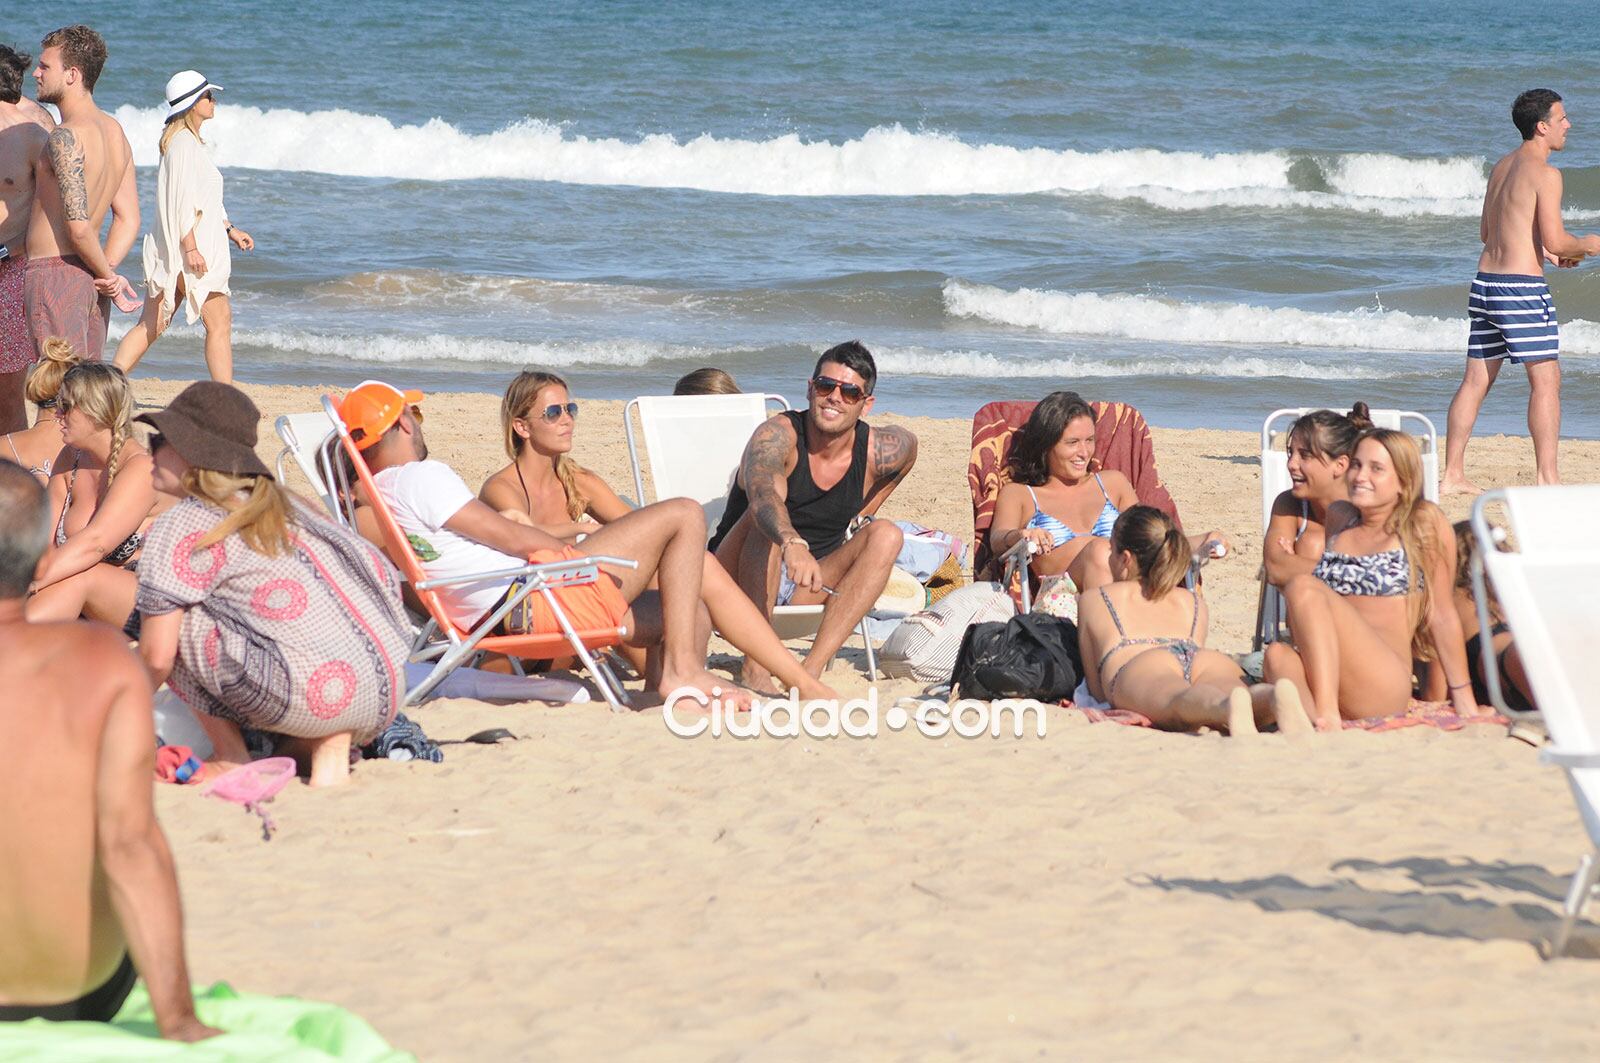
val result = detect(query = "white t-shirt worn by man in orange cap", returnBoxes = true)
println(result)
[373,461,528,628]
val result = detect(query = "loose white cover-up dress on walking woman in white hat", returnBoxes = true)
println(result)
[144,130,234,325]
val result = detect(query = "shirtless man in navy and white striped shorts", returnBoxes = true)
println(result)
[1438,88,1600,495]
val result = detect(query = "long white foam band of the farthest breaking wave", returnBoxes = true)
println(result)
[117,106,1510,215]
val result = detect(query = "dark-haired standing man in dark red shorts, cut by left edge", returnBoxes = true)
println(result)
[0,45,51,434]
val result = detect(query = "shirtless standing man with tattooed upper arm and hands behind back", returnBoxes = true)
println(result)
[24,26,139,362]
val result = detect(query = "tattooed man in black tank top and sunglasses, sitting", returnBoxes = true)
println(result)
[710,339,917,690]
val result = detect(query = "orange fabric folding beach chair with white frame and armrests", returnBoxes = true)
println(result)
[322,395,638,712]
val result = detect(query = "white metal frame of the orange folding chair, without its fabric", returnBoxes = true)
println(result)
[322,395,638,712]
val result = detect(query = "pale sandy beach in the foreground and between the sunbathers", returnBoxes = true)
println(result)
[134,376,1600,1060]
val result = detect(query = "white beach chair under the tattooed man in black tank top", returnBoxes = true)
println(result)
[622,394,878,679]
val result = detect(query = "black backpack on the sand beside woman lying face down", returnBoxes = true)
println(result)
[950,613,1083,701]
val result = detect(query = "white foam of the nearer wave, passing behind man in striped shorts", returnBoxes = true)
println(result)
[944,280,1600,354]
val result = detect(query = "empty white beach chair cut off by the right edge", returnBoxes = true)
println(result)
[1472,485,1600,959]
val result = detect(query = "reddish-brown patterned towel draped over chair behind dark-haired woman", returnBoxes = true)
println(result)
[966,400,1182,580]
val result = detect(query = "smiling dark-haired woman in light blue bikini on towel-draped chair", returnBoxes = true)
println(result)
[989,391,1227,592]
